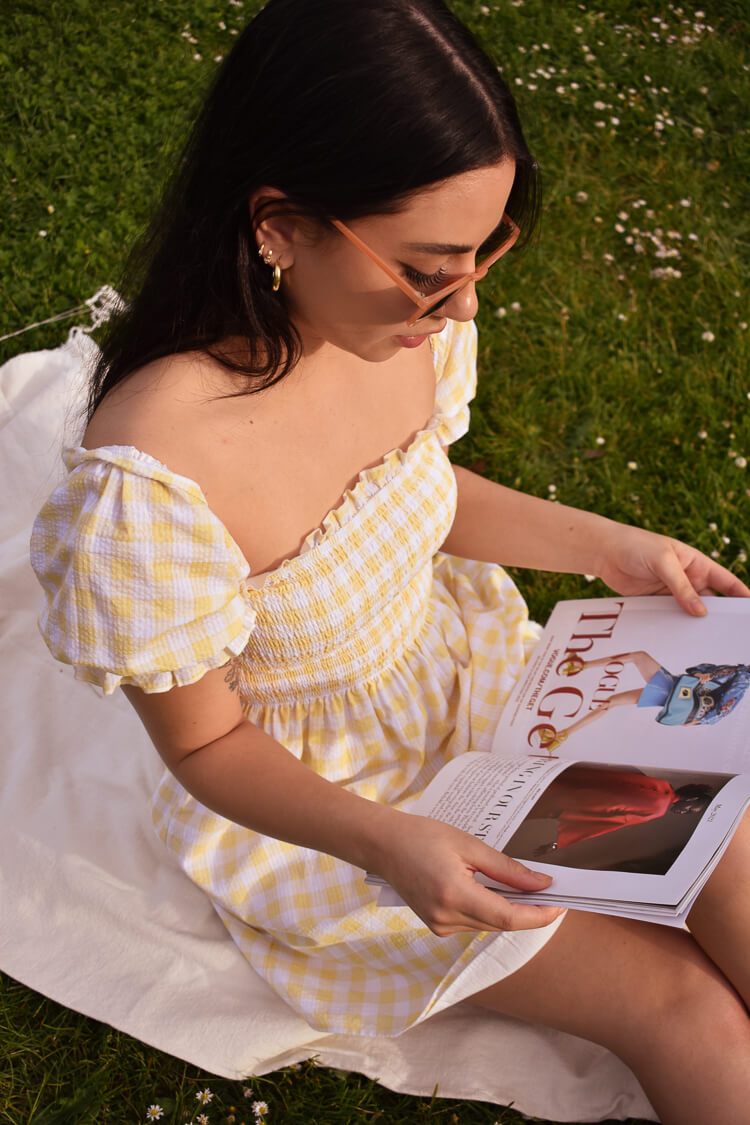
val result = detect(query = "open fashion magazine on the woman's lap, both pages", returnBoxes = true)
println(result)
[368,597,750,926]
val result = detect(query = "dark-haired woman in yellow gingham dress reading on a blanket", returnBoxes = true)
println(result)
[33,0,750,1122]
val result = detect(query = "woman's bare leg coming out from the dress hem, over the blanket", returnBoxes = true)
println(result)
[472,911,750,1125]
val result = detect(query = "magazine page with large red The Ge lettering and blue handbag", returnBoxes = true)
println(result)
[493,596,750,772]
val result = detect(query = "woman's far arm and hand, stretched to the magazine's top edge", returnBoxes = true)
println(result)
[442,466,750,617]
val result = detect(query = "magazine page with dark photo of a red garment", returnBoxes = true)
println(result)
[367,753,750,925]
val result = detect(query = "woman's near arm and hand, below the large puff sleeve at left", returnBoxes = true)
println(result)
[124,667,559,936]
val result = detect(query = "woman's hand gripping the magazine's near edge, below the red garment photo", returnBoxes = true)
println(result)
[377,812,563,937]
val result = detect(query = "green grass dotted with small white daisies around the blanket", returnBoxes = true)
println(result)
[0,0,750,1125]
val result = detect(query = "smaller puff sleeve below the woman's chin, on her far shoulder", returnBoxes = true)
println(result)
[433,321,477,446]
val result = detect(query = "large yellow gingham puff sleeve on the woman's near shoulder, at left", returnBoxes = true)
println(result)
[30,447,255,694]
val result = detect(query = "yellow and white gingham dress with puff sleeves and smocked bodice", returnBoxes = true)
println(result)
[31,323,555,1035]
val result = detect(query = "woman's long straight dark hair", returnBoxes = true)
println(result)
[89,0,539,417]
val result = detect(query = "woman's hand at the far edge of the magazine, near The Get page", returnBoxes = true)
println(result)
[598,523,750,617]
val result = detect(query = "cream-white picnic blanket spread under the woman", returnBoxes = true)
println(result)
[0,332,656,1122]
